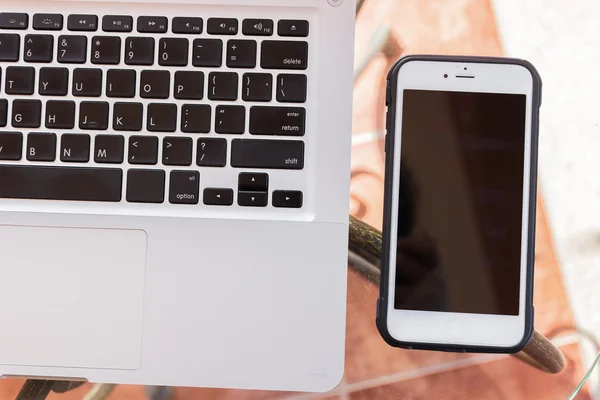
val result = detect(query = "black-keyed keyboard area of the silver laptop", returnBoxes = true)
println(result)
[0,12,310,208]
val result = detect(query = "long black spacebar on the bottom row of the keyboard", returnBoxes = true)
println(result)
[0,165,123,202]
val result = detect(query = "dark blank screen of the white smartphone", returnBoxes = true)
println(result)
[394,90,526,315]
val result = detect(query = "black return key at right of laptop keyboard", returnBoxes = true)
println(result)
[249,106,306,136]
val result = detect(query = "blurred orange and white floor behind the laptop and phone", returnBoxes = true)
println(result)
[0,0,600,400]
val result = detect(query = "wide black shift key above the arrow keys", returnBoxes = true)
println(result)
[231,139,304,169]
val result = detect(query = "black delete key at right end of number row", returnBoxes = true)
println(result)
[260,40,308,69]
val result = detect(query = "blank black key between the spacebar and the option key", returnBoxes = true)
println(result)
[126,169,165,204]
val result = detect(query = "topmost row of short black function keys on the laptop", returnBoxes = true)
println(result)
[0,12,309,37]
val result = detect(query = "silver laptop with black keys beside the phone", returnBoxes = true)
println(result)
[0,0,355,391]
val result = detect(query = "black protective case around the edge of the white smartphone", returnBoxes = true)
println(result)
[376,55,542,353]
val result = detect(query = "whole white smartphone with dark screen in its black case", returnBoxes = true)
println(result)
[377,56,541,353]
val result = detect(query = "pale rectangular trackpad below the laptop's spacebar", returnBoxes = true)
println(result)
[0,225,146,369]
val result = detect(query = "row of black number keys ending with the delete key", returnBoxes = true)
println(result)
[0,33,308,70]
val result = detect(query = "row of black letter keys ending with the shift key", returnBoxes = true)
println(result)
[0,132,304,169]
